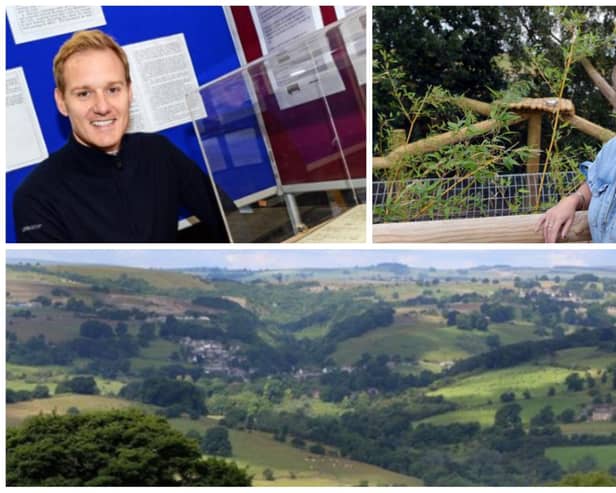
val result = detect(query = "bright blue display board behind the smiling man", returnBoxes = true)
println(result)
[6,7,275,242]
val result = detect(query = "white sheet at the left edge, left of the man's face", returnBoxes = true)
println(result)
[5,67,49,171]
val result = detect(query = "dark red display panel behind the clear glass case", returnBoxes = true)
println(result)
[231,7,366,189]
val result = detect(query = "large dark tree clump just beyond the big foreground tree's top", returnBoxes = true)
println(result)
[119,377,207,419]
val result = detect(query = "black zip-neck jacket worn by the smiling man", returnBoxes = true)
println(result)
[13,133,229,243]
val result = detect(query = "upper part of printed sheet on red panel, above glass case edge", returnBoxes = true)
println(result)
[250,6,323,55]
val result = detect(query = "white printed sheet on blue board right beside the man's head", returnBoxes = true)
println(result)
[124,33,205,132]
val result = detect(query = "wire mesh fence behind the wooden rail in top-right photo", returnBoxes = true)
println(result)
[372,172,579,223]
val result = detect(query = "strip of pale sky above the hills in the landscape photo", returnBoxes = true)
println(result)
[6,247,616,270]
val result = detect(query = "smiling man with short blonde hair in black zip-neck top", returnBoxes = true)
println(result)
[13,30,230,243]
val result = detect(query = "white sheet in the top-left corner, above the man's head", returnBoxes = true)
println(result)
[6,5,106,44]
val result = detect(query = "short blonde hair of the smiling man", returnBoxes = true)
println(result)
[53,29,130,94]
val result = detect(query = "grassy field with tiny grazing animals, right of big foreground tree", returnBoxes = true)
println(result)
[170,418,422,486]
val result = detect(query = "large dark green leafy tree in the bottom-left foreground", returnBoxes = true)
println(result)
[6,409,251,486]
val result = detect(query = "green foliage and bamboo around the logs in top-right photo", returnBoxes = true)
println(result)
[373,6,616,222]
